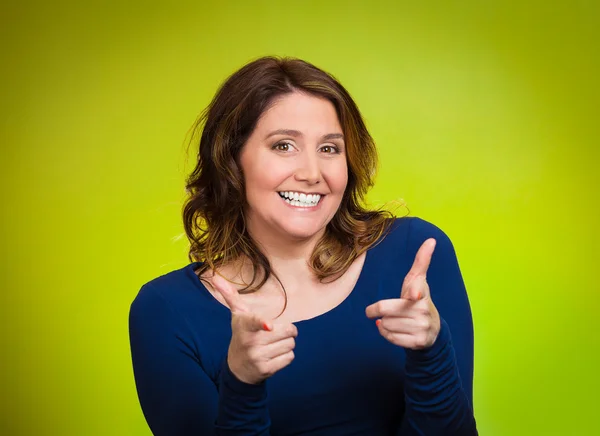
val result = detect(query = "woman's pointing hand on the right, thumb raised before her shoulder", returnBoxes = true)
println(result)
[366,238,440,350]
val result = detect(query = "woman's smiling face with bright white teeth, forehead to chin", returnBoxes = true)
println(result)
[240,92,348,244]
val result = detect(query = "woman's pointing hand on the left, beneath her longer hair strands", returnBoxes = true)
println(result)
[211,274,298,384]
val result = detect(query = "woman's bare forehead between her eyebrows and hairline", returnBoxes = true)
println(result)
[256,92,342,133]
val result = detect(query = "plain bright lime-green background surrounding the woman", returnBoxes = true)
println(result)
[0,0,600,436]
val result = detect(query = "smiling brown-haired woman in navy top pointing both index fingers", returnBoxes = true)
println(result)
[130,57,476,436]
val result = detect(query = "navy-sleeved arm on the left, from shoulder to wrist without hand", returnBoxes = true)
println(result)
[129,285,270,436]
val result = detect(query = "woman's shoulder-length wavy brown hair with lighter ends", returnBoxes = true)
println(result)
[183,56,393,293]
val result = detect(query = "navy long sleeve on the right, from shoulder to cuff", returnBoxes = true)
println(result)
[399,219,477,436]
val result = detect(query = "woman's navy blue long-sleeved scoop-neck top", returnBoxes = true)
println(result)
[129,218,477,436]
